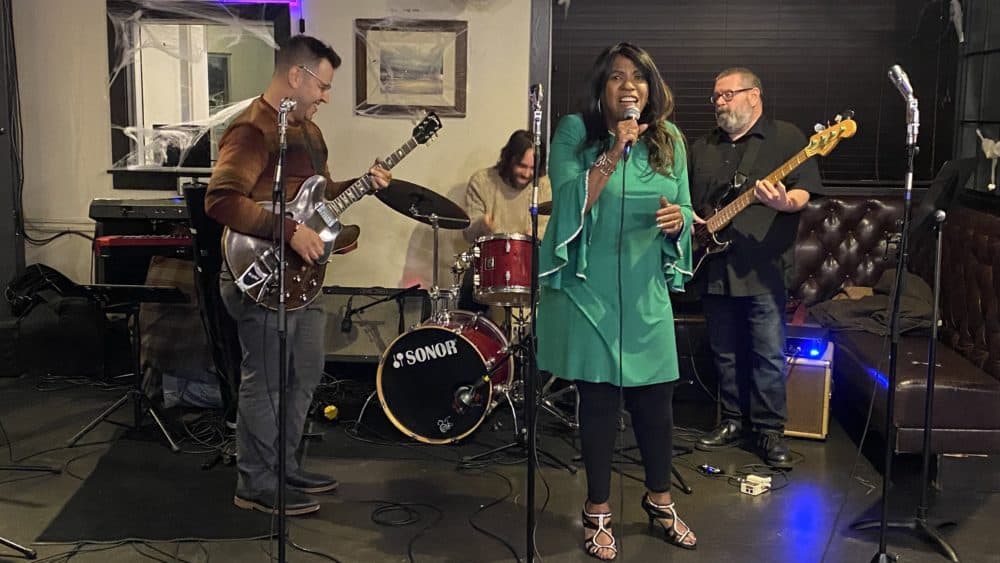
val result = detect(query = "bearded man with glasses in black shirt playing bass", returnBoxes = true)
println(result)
[689,68,821,468]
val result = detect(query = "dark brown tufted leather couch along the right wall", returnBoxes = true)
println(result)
[678,194,1000,454]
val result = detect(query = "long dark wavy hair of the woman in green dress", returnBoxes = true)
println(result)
[582,43,683,174]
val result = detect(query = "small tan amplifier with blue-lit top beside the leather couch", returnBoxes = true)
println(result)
[785,342,833,440]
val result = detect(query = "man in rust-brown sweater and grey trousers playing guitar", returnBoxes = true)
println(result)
[205,35,391,515]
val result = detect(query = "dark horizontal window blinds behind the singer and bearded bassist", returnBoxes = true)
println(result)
[552,0,958,187]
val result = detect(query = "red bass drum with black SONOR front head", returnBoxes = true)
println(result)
[376,311,513,444]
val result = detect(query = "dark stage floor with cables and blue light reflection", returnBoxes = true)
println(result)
[0,370,1000,563]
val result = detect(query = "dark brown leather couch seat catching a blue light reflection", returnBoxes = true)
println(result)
[834,331,1000,436]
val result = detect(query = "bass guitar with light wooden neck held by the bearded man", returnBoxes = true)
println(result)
[691,112,858,274]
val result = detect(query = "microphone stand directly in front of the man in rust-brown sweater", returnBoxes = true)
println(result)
[271,98,295,563]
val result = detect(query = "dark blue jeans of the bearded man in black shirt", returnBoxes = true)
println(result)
[702,293,788,432]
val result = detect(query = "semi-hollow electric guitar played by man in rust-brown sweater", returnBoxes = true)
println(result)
[222,112,441,311]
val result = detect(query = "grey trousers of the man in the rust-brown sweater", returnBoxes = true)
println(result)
[219,272,326,495]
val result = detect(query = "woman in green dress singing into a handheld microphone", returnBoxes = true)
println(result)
[538,43,697,560]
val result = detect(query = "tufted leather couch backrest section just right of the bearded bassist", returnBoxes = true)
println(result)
[790,196,903,305]
